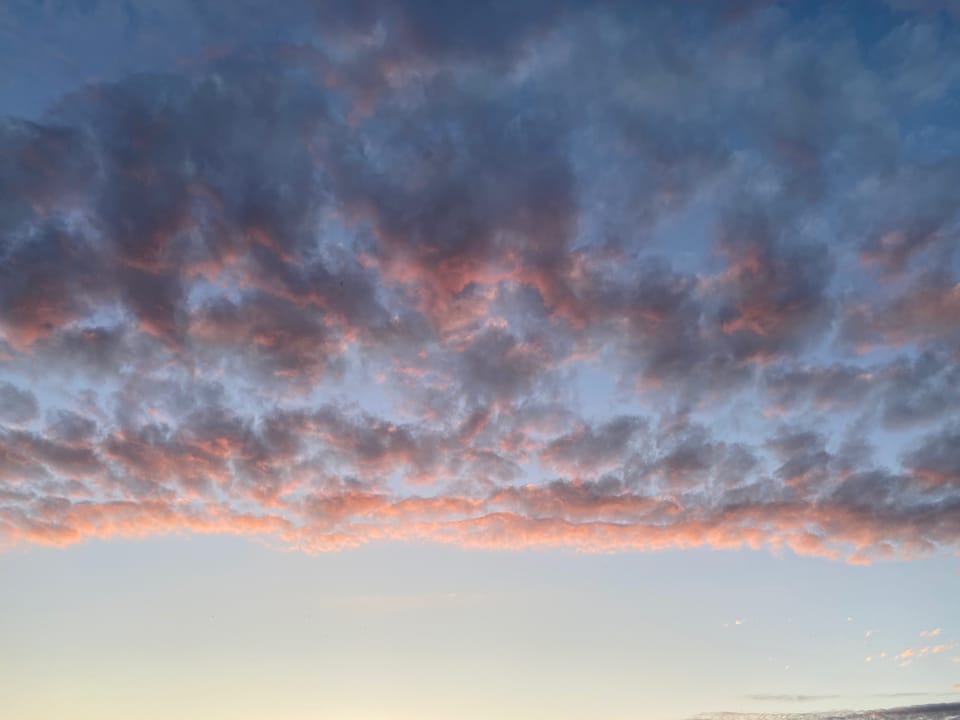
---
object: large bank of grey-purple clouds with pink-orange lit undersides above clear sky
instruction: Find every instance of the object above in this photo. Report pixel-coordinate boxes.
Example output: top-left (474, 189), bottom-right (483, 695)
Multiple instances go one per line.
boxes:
top-left (0, 1), bottom-right (960, 562)
